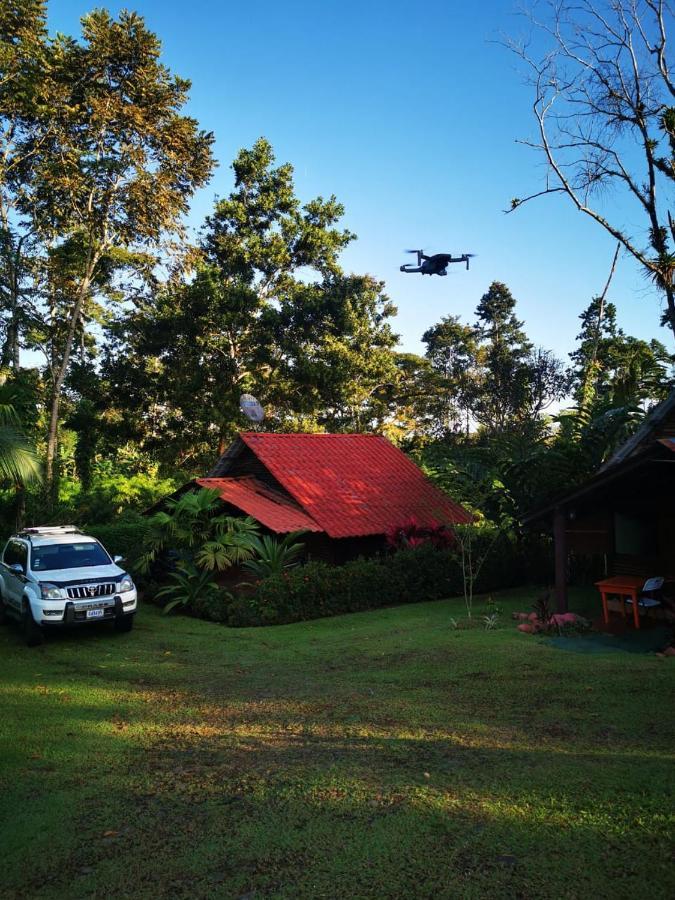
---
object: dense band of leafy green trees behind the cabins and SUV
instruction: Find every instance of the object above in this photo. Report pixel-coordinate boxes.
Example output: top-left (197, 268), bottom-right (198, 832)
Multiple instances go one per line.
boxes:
top-left (0, 0), bottom-right (674, 568)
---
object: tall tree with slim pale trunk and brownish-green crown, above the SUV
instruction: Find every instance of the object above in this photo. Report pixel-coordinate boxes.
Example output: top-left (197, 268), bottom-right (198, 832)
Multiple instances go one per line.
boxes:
top-left (13, 10), bottom-right (213, 482)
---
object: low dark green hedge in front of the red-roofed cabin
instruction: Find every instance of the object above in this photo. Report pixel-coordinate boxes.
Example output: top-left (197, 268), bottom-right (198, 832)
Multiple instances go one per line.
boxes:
top-left (227, 536), bottom-right (548, 626)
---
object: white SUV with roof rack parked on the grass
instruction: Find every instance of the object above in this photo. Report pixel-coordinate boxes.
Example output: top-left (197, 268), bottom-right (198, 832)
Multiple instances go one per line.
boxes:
top-left (0, 525), bottom-right (136, 646)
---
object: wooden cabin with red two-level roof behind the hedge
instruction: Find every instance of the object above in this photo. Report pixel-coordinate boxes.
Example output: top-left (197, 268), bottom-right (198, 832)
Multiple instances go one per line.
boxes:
top-left (164, 432), bottom-right (472, 563)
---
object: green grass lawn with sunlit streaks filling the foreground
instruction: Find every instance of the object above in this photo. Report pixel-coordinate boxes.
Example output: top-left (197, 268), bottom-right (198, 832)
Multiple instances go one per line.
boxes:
top-left (0, 590), bottom-right (675, 900)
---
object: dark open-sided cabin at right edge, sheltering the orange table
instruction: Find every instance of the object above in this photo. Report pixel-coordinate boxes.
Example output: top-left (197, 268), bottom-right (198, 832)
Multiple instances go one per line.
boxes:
top-left (524, 391), bottom-right (675, 611)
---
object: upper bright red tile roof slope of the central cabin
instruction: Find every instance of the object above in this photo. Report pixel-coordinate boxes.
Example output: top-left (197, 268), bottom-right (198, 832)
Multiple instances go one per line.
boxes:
top-left (240, 432), bottom-right (471, 538)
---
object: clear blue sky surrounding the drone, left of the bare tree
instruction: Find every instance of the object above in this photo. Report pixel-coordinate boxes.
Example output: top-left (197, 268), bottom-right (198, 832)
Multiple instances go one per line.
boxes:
top-left (50, 0), bottom-right (672, 358)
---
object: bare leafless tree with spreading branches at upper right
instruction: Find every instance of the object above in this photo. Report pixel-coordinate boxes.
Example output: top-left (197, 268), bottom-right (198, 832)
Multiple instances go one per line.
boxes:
top-left (509, 0), bottom-right (675, 334)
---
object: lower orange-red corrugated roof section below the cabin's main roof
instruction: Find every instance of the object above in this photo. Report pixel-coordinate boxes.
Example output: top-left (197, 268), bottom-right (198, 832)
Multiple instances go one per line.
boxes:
top-left (197, 477), bottom-right (323, 534)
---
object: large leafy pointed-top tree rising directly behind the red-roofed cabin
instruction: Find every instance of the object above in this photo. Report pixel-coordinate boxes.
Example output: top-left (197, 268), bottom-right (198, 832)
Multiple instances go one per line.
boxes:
top-left (104, 138), bottom-right (398, 468)
